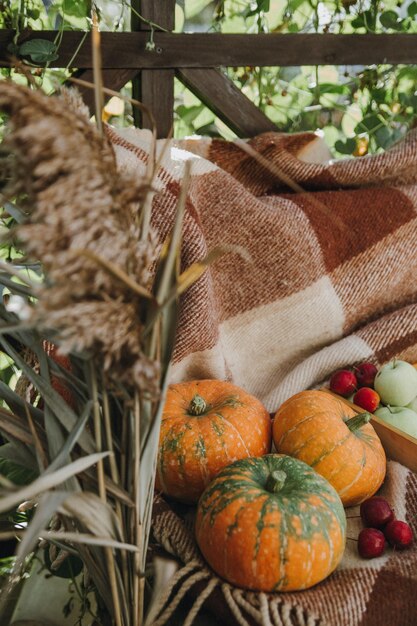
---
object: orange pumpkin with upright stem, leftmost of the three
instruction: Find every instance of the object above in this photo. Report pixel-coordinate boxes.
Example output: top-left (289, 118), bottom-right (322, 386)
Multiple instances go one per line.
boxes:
top-left (156, 380), bottom-right (272, 503)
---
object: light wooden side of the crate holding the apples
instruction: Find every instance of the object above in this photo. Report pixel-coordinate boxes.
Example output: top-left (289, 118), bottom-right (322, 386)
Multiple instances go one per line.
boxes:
top-left (321, 388), bottom-right (417, 472)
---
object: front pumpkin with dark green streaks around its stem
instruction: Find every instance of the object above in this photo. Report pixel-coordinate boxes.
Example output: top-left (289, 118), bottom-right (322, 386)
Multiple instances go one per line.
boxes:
top-left (196, 454), bottom-right (346, 592)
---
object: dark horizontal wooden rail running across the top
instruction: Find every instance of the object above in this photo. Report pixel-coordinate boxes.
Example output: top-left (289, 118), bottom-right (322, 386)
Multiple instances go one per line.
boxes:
top-left (0, 30), bottom-right (417, 69)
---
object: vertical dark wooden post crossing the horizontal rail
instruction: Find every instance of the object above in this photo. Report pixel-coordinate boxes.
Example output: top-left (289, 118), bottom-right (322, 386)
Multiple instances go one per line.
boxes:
top-left (131, 0), bottom-right (175, 137)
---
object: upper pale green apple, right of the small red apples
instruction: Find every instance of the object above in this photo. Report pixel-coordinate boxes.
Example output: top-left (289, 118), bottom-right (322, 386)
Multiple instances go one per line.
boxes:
top-left (374, 359), bottom-right (417, 406)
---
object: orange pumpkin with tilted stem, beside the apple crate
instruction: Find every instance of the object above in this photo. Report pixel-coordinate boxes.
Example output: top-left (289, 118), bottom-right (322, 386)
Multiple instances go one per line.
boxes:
top-left (273, 391), bottom-right (386, 506)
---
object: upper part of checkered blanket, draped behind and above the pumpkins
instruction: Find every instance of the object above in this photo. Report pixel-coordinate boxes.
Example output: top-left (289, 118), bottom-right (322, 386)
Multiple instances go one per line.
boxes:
top-left (109, 129), bottom-right (417, 412)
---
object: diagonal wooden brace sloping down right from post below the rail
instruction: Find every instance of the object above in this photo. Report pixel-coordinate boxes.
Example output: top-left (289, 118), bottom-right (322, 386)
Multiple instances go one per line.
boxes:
top-left (177, 69), bottom-right (277, 137)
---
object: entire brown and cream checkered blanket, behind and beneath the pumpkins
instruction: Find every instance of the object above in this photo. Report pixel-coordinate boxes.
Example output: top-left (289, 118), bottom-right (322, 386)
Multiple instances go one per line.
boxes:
top-left (108, 129), bottom-right (417, 626)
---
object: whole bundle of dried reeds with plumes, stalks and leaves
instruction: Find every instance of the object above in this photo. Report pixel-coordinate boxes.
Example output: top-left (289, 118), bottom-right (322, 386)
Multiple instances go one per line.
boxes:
top-left (0, 81), bottom-right (191, 626)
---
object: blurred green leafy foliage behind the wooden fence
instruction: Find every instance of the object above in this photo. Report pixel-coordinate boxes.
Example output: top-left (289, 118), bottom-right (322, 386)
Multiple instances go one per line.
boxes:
top-left (0, 0), bottom-right (417, 156)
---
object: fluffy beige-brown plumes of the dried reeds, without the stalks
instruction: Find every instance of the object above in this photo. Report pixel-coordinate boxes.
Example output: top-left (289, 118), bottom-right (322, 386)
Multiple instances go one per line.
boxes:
top-left (0, 81), bottom-right (159, 394)
